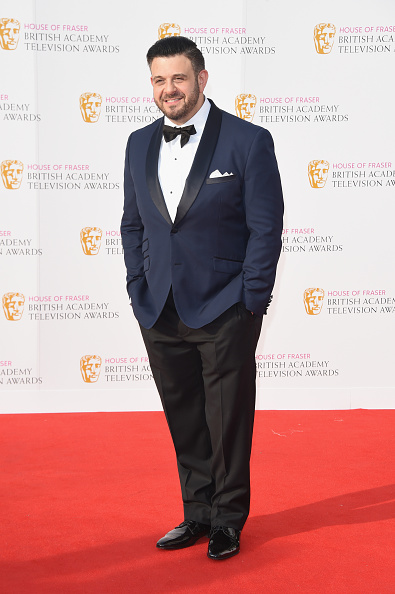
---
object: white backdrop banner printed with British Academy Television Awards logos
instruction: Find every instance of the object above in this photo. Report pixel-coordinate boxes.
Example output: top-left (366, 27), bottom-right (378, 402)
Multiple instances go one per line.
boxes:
top-left (0, 0), bottom-right (395, 413)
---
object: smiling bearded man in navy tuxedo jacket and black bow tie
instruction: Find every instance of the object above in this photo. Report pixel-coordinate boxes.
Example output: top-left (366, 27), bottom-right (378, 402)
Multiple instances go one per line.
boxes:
top-left (121, 36), bottom-right (283, 559)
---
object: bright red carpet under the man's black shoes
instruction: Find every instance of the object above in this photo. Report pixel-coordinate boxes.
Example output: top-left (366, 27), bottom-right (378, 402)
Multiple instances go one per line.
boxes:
top-left (0, 410), bottom-right (395, 594)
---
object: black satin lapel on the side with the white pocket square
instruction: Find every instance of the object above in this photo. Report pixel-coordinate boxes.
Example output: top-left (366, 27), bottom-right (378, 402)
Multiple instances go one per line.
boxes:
top-left (174, 101), bottom-right (222, 225)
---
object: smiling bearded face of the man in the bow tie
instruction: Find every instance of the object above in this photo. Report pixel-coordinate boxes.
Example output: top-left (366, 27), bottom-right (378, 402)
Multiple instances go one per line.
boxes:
top-left (151, 55), bottom-right (208, 125)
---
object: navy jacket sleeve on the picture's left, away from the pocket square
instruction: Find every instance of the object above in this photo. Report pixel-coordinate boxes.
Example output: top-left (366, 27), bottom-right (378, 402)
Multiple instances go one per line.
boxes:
top-left (121, 134), bottom-right (144, 297)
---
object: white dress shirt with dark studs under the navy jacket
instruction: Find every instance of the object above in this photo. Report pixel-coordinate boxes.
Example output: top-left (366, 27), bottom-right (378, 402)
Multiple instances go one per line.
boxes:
top-left (158, 98), bottom-right (211, 222)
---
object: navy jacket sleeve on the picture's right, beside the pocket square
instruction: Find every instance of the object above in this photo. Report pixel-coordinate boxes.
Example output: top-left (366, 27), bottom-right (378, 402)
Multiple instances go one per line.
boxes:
top-left (243, 128), bottom-right (284, 315)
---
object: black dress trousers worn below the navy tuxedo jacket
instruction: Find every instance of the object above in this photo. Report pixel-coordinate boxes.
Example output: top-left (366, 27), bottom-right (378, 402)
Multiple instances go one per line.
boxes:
top-left (141, 291), bottom-right (262, 529)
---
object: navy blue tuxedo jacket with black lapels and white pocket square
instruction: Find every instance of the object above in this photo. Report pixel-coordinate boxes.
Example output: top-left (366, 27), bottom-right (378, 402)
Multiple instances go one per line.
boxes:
top-left (121, 102), bottom-right (283, 328)
